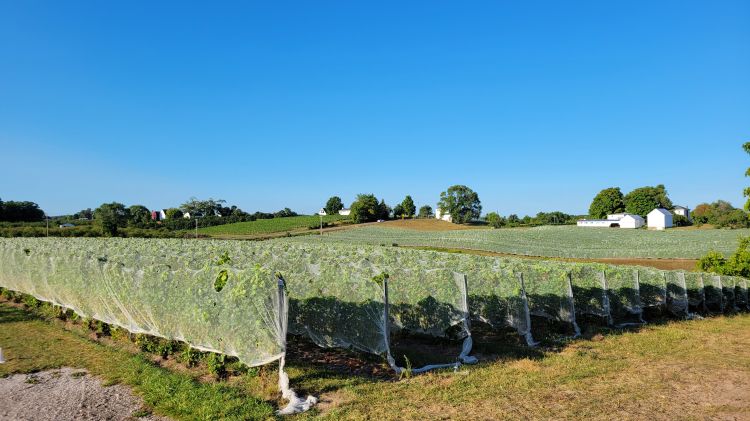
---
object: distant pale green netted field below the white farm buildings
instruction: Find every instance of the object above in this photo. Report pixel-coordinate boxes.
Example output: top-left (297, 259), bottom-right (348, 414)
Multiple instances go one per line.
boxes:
top-left (293, 226), bottom-right (750, 259)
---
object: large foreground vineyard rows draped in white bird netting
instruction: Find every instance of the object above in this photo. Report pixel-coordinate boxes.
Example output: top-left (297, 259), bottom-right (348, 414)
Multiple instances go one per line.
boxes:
top-left (0, 238), bottom-right (750, 414)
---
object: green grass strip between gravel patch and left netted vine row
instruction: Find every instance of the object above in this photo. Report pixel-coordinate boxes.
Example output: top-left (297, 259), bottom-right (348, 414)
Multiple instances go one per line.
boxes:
top-left (0, 304), bottom-right (274, 420)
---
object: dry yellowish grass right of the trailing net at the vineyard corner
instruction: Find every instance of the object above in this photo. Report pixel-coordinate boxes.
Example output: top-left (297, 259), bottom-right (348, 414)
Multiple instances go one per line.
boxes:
top-left (310, 314), bottom-right (750, 420)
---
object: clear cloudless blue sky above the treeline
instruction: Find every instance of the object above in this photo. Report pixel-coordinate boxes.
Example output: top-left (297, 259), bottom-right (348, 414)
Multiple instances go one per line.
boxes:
top-left (0, 0), bottom-right (750, 215)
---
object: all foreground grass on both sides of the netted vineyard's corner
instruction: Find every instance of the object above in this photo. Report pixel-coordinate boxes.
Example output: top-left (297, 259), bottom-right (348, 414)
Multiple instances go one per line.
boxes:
top-left (0, 304), bottom-right (750, 420)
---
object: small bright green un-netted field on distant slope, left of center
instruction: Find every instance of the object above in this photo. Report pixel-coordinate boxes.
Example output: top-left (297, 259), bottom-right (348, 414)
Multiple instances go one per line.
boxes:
top-left (198, 215), bottom-right (349, 236)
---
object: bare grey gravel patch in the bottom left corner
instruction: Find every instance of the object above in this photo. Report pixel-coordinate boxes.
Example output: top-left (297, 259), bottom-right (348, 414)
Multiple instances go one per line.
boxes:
top-left (0, 368), bottom-right (167, 421)
